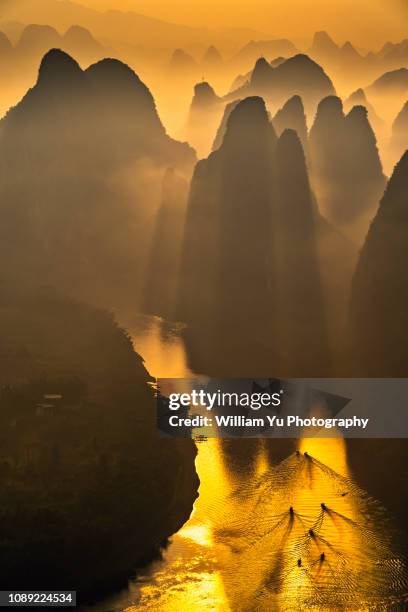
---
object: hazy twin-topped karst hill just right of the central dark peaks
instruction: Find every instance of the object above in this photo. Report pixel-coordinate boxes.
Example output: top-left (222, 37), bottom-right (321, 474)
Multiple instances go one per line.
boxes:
top-left (309, 96), bottom-right (385, 241)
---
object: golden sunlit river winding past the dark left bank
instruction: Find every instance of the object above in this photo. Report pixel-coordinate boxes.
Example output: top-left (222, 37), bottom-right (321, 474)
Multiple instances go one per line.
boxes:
top-left (85, 316), bottom-right (407, 612)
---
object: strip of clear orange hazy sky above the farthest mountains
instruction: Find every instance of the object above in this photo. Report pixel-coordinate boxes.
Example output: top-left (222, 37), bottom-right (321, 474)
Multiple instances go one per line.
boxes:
top-left (76, 0), bottom-right (408, 45)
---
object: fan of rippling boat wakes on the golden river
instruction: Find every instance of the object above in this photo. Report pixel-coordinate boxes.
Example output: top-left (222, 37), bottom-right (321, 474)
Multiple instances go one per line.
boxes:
top-left (213, 452), bottom-right (408, 610)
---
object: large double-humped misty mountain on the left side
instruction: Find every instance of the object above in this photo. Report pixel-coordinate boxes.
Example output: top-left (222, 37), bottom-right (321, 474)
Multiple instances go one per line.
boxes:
top-left (0, 50), bottom-right (195, 305)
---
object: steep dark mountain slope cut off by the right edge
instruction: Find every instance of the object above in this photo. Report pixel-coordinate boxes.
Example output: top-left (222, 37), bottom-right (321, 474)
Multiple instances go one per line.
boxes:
top-left (350, 153), bottom-right (408, 377)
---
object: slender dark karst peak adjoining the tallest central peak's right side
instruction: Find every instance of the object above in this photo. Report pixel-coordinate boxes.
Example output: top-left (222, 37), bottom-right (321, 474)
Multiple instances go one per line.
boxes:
top-left (274, 129), bottom-right (329, 376)
